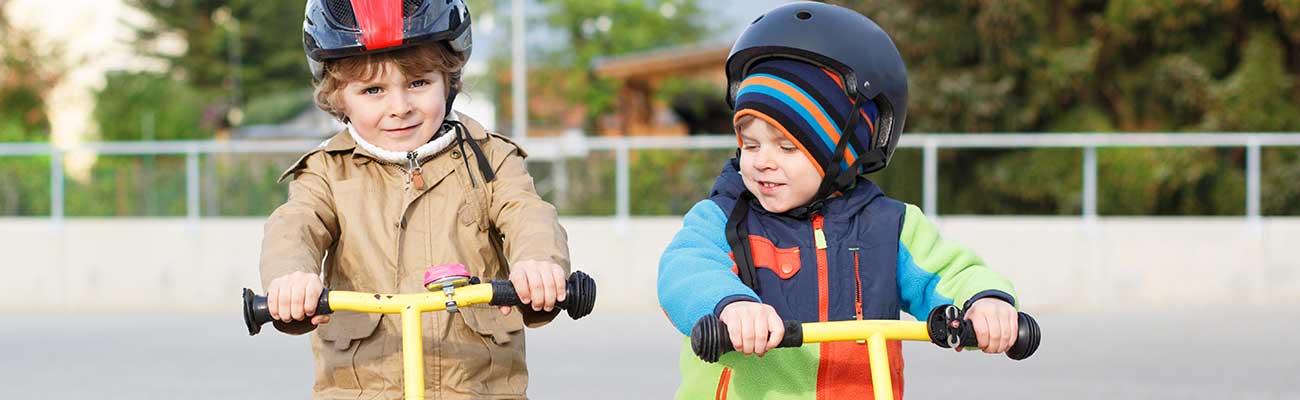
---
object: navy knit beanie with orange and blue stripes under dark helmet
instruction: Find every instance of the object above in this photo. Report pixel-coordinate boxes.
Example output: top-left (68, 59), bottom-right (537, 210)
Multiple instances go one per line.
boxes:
top-left (733, 58), bottom-right (878, 177)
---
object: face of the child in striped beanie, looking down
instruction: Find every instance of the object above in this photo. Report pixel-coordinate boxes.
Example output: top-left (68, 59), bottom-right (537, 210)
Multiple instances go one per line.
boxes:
top-left (737, 119), bottom-right (822, 213)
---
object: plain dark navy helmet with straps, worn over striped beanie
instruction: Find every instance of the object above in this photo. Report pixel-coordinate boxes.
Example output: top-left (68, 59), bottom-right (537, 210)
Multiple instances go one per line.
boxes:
top-left (725, 1), bottom-right (907, 290)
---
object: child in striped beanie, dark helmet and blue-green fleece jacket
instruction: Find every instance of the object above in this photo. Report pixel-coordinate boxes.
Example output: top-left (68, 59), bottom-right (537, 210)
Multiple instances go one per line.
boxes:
top-left (658, 3), bottom-right (1018, 399)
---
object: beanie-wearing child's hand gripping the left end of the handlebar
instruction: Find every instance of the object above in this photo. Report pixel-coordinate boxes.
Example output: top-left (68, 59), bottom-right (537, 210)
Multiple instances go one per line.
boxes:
top-left (718, 301), bottom-right (785, 357)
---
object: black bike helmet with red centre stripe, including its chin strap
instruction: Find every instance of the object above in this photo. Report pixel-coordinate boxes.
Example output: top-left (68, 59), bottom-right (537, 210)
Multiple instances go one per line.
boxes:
top-left (303, 0), bottom-right (495, 182)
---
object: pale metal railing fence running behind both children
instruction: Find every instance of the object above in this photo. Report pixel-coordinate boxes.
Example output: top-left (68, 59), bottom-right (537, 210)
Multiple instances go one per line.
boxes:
top-left (0, 132), bottom-right (1300, 222)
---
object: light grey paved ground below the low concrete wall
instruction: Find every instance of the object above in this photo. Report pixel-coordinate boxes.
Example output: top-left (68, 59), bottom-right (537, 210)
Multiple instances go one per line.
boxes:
top-left (0, 308), bottom-right (1300, 399)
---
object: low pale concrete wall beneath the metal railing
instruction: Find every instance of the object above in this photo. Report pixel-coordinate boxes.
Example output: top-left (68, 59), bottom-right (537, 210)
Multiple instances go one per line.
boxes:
top-left (0, 217), bottom-right (1300, 312)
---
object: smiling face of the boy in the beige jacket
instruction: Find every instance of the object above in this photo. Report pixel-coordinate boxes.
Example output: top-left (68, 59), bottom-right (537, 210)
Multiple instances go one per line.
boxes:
top-left (342, 64), bottom-right (447, 152)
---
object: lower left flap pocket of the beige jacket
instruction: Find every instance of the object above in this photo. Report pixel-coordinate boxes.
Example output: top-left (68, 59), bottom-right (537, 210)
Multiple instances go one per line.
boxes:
top-left (316, 312), bottom-right (380, 390)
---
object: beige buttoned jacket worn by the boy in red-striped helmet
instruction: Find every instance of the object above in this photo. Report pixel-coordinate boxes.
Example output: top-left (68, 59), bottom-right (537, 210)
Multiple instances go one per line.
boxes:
top-left (261, 116), bottom-right (569, 399)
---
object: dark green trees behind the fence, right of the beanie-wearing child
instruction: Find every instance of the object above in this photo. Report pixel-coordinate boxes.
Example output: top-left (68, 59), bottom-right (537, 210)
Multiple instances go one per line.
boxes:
top-left (832, 0), bottom-right (1300, 214)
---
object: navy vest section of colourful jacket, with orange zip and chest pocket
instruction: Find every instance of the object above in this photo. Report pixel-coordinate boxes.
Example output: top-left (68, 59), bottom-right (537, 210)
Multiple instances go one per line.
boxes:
top-left (710, 158), bottom-right (906, 322)
